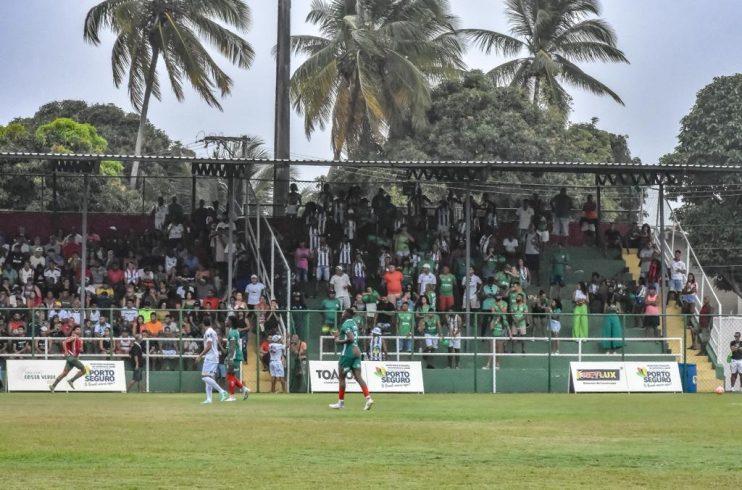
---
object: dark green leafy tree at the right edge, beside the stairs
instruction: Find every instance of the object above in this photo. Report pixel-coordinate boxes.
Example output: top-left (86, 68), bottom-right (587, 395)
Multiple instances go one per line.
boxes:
top-left (661, 74), bottom-right (742, 295)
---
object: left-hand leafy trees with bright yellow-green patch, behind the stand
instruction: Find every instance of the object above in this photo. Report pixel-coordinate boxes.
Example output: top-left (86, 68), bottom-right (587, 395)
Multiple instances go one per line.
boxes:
top-left (0, 100), bottom-right (198, 212)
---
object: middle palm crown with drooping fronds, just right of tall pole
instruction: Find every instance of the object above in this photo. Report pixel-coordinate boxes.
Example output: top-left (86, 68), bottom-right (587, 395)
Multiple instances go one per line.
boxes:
top-left (291, 0), bottom-right (464, 160)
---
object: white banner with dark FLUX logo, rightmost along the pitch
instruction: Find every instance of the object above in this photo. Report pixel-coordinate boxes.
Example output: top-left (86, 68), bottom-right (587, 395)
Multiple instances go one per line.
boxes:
top-left (569, 362), bottom-right (683, 393)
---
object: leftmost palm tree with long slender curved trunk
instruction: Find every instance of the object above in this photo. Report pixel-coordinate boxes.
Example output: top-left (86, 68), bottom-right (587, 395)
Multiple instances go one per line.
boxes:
top-left (83, 0), bottom-right (255, 187)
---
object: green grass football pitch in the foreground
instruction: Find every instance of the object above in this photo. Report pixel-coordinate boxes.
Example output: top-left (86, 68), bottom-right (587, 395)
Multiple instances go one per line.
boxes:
top-left (0, 393), bottom-right (742, 489)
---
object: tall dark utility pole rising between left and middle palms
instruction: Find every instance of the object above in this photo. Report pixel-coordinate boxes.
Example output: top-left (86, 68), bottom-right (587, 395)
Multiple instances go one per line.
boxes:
top-left (273, 0), bottom-right (291, 216)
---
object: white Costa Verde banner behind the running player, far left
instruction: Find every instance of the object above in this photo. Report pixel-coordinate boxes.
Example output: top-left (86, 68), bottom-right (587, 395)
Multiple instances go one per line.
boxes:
top-left (7, 359), bottom-right (126, 393)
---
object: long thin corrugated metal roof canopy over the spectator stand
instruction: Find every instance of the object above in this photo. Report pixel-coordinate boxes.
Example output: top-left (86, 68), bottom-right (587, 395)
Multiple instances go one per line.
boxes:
top-left (0, 152), bottom-right (742, 186)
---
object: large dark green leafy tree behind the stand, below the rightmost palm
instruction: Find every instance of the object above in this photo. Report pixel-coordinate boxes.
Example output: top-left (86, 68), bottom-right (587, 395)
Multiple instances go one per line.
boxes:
top-left (331, 71), bottom-right (640, 210)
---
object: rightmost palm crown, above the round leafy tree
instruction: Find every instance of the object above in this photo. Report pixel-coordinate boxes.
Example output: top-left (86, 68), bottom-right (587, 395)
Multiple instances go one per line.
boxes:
top-left (459, 0), bottom-right (628, 114)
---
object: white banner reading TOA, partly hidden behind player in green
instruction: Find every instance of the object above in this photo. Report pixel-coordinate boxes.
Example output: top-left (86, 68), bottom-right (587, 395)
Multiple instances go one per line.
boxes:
top-left (309, 361), bottom-right (425, 393)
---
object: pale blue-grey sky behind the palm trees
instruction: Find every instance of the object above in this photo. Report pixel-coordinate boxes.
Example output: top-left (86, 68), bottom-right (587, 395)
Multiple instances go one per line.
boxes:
top-left (0, 0), bottom-right (742, 179)
